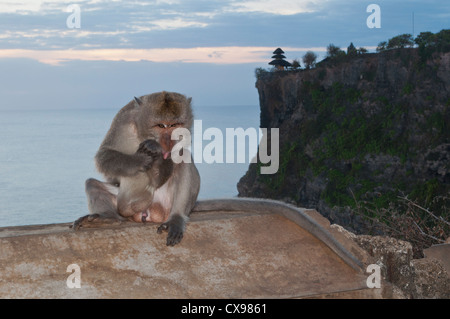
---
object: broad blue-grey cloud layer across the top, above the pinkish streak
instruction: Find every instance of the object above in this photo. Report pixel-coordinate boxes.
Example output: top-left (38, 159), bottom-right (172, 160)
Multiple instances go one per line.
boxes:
top-left (0, 0), bottom-right (448, 54)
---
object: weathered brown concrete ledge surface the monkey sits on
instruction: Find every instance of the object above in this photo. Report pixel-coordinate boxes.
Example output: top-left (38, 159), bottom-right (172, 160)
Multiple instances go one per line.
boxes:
top-left (0, 211), bottom-right (381, 298)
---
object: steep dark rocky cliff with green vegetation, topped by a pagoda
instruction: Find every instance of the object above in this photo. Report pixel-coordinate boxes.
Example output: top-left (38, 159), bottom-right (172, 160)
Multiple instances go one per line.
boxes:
top-left (238, 49), bottom-right (450, 233)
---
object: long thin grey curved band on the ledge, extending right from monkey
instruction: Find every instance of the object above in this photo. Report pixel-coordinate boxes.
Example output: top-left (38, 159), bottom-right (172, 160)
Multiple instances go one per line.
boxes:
top-left (192, 198), bottom-right (363, 272)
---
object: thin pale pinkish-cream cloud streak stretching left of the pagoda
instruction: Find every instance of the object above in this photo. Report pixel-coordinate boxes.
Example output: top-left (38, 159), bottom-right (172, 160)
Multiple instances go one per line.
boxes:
top-left (0, 46), bottom-right (326, 65)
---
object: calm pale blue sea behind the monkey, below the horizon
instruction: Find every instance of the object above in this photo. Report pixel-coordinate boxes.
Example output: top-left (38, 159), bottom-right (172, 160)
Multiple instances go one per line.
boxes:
top-left (0, 106), bottom-right (259, 227)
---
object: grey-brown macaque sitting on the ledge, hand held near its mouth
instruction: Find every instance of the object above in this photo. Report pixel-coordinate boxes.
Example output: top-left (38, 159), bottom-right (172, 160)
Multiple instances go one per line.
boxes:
top-left (72, 92), bottom-right (200, 246)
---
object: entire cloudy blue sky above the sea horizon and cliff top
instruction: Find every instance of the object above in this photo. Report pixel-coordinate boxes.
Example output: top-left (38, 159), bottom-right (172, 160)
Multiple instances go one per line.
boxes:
top-left (0, 0), bottom-right (450, 110)
